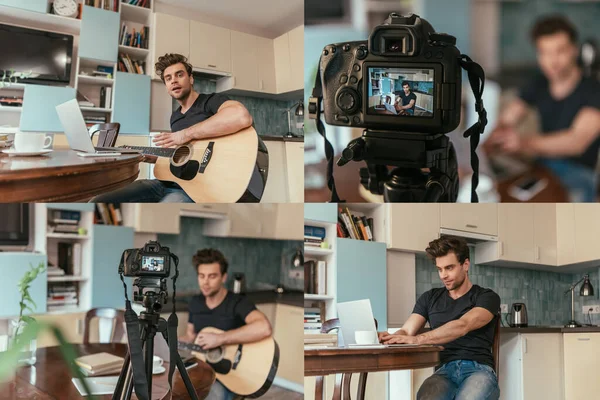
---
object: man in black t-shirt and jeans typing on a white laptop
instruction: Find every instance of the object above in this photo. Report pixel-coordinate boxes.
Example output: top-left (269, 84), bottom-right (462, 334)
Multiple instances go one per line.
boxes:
top-left (379, 237), bottom-right (500, 400)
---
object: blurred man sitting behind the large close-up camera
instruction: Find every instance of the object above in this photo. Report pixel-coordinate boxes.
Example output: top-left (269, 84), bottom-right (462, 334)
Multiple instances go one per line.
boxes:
top-left (485, 16), bottom-right (600, 202)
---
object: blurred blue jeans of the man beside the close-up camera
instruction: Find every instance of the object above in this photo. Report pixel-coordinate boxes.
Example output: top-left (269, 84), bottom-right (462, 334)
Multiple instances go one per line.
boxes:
top-left (540, 159), bottom-right (597, 203)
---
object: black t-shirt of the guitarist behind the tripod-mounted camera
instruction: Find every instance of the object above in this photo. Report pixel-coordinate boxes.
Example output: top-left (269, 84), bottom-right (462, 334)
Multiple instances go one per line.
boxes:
top-left (188, 292), bottom-right (256, 333)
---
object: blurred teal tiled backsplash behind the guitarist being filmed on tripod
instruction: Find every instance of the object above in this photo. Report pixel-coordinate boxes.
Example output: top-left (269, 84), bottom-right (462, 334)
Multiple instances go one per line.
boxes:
top-left (158, 217), bottom-right (304, 291)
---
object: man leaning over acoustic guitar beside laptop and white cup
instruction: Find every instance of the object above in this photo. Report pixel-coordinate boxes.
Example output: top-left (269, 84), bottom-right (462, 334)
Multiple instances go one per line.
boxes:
top-left (92, 54), bottom-right (266, 203)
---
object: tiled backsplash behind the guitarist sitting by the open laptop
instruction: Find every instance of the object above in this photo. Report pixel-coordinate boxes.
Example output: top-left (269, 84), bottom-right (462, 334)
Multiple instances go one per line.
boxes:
top-left (173, 77), bottom-right (304, 136)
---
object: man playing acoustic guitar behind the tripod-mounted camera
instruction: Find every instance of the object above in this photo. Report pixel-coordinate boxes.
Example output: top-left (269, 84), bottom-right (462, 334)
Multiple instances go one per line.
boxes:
top-left (179, 249), bottom-right (279, 400)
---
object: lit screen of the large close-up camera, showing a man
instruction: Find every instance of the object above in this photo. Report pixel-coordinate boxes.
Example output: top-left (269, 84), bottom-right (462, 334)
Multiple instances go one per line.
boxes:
top-left (367, 68), bottom-right (435, 118)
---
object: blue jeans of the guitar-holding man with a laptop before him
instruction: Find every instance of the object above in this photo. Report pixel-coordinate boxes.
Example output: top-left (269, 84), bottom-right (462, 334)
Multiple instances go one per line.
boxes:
top-left (90, 179), bottom-right (194, 203)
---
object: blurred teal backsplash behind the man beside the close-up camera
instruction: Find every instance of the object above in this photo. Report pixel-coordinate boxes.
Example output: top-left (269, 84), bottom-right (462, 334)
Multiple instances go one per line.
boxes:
top-left (500, 0), bottom-right (600, 66)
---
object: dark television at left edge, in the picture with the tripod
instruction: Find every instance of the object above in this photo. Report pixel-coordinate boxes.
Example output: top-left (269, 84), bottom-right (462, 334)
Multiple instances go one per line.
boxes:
top-left (0, 203), bottom-right (34, 251)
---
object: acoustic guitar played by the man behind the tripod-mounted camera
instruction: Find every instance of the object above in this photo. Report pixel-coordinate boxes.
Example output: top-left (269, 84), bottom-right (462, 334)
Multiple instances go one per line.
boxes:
top-left (178, 327), bottom-right (279, 398)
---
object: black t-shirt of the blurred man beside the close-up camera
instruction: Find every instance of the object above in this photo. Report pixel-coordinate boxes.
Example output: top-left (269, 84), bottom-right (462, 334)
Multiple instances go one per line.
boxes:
top-left (519, 74), bottom-right (600, 169)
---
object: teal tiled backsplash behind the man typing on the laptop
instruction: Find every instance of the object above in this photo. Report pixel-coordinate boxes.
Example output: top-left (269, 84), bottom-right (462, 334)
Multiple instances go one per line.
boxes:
top-left (416, 254), bottom-right (600, 326)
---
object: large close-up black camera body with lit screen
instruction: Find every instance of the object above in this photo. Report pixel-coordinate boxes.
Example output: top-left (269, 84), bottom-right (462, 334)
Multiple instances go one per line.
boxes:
top-left (316, 13), bottom-right (461, 134)
